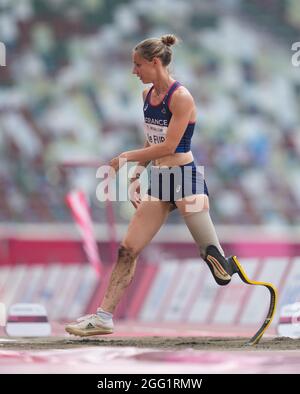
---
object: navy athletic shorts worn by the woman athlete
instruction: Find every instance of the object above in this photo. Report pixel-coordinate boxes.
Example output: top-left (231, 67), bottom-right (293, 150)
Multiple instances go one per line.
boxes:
top-left (147, 161), bottom-right (208, 204)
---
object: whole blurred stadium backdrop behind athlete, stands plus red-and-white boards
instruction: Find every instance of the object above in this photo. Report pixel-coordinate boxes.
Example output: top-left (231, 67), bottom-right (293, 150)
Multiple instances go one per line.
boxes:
top-left (0, 0), bottom-right (300, 336)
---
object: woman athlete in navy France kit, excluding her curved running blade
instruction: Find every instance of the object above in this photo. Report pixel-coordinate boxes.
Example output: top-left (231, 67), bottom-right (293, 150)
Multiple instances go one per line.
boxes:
top-left (66, 35), bottom-right (239, 336)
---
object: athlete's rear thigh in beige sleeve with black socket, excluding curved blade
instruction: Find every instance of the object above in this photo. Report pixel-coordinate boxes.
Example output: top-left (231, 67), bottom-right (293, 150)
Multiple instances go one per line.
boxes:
top-left (176, 194), bottom-right (233, 286)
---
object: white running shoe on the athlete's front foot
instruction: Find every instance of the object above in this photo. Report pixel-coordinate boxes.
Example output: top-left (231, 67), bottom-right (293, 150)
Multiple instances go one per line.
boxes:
top-left (65, 315), bottom-right (114, 337)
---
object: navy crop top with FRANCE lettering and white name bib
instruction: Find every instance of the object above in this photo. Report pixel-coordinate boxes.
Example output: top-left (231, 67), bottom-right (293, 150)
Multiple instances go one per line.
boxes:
top-left (144, 81), bottom-right (195, 153)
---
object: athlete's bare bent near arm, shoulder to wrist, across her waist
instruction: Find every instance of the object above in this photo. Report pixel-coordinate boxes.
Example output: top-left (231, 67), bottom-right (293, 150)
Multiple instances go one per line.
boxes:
top-left (119, 89), bottom-right (194, 162)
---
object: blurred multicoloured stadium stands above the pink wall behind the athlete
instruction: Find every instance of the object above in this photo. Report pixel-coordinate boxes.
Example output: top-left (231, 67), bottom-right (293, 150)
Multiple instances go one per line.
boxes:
top-left (0, 0), bottom-right (300, 225)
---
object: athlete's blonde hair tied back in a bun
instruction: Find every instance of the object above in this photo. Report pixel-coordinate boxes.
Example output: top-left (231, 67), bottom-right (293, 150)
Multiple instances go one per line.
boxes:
top-left (134, 34), bottom-right (179, 67)
